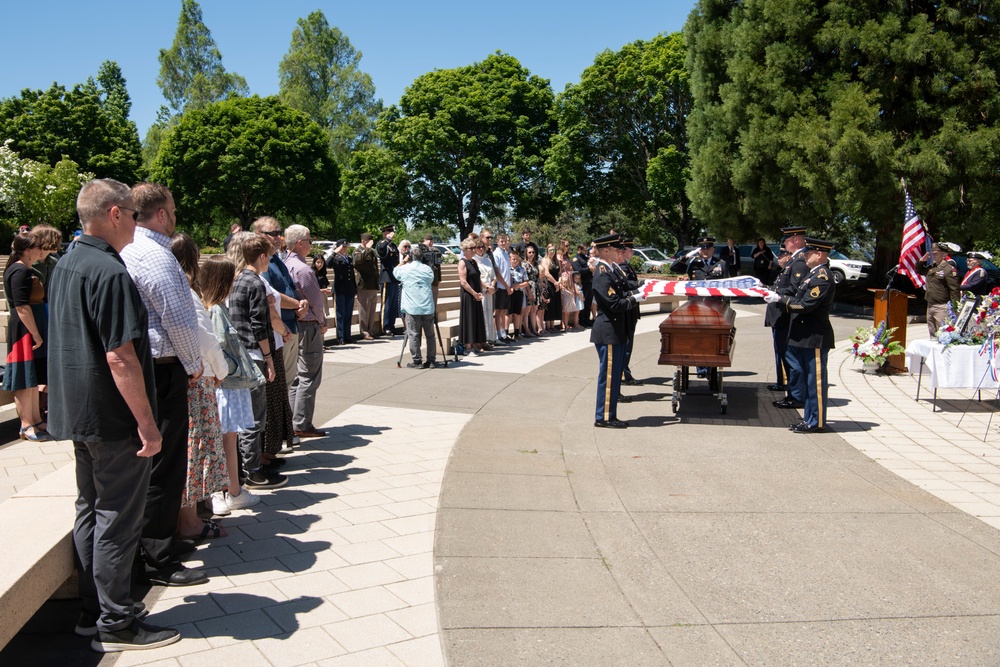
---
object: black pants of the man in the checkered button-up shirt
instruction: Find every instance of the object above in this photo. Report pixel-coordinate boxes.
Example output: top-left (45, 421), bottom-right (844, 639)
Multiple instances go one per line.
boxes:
top-left (139, 362), bottom-right (188, 569)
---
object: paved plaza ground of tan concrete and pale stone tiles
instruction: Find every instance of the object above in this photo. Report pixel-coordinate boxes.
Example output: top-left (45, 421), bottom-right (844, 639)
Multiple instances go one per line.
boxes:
top-left (0, 305), bottom-right (1000, 667)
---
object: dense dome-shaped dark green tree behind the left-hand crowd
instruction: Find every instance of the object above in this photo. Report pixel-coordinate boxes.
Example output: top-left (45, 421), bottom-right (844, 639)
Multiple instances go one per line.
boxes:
top-left (151, 96), bottom-right (340, 243)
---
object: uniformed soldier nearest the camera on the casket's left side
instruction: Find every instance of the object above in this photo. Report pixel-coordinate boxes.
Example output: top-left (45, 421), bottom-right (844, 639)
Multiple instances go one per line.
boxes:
top-left (590, 234), bottom-right (646, 428)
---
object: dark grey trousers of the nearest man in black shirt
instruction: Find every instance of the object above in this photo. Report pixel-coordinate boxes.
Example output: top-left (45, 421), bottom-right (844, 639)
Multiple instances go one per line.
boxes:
top-left (75, 437), bottom-right (152, 632)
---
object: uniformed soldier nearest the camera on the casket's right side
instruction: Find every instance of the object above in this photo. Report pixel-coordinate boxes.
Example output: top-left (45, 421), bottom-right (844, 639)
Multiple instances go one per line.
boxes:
top-left (764, 238), bottom-right (836, 433)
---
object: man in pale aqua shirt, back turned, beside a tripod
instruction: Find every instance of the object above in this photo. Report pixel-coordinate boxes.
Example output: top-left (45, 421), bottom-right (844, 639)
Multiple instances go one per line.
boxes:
top-left (392, 245), bottom-right (440, 368)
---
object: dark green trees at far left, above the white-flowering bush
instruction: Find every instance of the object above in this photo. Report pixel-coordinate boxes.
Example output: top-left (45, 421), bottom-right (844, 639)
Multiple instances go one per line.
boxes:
top-left (0, 61), bottom-right (141, 183)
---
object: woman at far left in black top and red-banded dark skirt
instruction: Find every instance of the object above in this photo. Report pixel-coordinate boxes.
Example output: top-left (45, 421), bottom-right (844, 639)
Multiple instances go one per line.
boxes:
top-left (3, 232), bottom-right (50, 440)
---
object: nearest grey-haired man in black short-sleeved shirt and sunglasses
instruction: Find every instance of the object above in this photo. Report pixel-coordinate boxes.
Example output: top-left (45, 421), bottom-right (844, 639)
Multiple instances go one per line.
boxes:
top-left (48, 179), bottom-right (180, 653)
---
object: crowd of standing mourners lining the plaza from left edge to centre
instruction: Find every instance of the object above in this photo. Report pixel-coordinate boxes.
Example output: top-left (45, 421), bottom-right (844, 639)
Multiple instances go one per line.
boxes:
top-left (3, 179), bottom-right (592, 652)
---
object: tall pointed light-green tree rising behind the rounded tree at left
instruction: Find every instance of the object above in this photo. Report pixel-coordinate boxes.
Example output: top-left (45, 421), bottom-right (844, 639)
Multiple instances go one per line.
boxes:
top-left (156, 0), bottom-right (249, 114)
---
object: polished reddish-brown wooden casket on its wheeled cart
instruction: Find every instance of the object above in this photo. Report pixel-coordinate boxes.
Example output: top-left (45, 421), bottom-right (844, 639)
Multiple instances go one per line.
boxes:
top-left (657, 297), bottom-right (736, 414)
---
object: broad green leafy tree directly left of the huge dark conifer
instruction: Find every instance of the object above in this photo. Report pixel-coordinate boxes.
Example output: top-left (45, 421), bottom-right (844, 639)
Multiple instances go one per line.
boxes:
top-left (545, 33), bottom-right (698, 244)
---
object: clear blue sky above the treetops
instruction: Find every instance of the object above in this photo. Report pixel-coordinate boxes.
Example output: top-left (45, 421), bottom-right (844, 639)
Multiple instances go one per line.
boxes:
top-left (0, 0), bottom-right (694, 137)
